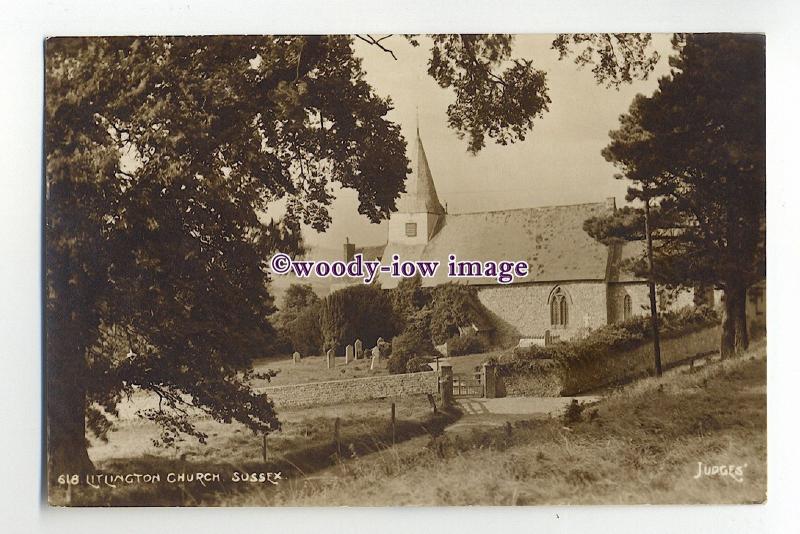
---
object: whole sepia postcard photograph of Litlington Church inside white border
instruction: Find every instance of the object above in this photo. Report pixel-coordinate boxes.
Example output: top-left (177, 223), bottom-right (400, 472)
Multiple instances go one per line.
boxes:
top-left (41, 31), bottom-right (768, 507)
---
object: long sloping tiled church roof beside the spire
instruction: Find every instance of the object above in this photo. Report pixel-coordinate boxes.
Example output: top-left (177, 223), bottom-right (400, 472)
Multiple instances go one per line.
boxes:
top-left (381, 202), bottom-right (648, 288)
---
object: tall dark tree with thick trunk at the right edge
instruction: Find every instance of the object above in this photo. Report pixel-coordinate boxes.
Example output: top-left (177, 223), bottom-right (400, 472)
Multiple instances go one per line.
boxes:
top-left (586, 34), bottom-right (766, 356)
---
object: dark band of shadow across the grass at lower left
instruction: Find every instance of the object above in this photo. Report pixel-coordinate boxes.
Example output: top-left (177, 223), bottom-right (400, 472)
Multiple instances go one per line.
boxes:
top-left (49, 408), bottom-right (463, 506)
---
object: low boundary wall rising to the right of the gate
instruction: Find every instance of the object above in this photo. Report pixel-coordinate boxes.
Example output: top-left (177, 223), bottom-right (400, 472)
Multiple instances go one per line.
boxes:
top-left (500, 326), bottom-right (720, 397)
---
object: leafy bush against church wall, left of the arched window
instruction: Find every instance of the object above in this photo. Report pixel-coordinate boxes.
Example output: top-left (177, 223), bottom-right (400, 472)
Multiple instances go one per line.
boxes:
top-left (431, 282), bottom-right (488, 345)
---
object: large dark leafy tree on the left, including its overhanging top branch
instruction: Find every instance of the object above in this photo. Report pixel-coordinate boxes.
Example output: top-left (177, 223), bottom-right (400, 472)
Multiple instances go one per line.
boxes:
top-left (40, 35), bottom-right (660, 478)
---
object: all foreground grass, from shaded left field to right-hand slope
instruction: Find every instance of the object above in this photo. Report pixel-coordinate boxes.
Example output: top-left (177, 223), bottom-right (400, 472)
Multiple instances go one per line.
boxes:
top-left (51, 342), bottom-right (766, 506)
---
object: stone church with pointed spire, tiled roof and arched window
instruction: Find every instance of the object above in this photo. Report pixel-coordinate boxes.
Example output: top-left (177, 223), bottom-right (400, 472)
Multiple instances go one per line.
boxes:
top-left (344, 131), bottom-right (691, 346)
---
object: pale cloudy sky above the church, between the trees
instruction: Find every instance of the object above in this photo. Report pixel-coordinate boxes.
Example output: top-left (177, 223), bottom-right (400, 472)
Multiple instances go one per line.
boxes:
top-left (303, 34), bottom-right (671, 253)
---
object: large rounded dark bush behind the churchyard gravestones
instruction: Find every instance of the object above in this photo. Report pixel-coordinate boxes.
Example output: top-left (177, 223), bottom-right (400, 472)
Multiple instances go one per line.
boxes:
top-left (320, 284), bottom-right (398, 354)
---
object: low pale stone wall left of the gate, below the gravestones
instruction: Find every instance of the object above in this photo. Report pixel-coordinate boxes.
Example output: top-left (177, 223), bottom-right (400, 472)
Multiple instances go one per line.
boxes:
top-left (256, 371), bottom-right (439, 408)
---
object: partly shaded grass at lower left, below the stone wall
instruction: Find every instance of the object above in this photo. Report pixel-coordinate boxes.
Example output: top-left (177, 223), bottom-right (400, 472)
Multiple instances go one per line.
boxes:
top-left (50, 397), bottom-right (460, 506)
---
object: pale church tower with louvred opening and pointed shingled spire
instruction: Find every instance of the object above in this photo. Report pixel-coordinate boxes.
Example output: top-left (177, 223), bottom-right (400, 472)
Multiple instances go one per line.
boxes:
top-left (389, 128), bottom-right (445, 245)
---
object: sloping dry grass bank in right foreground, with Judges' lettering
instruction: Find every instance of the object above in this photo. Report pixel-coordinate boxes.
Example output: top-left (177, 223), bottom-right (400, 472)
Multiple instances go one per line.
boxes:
top-left (235, 343), bottom-right (766, 506)
